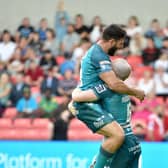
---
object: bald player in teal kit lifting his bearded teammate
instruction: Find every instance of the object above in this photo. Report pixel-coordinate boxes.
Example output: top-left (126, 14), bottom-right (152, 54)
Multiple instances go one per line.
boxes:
top-left (72, 59), bottom-right (141, 168)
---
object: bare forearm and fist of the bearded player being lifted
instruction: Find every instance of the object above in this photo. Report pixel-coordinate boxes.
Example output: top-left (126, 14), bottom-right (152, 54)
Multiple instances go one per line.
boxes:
top-left (99, 70), bottom-right (144, 100)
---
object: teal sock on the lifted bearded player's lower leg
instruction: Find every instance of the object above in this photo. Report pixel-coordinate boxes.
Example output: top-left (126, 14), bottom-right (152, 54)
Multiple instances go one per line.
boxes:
top-left (94, 147), bottom-right (114, 168)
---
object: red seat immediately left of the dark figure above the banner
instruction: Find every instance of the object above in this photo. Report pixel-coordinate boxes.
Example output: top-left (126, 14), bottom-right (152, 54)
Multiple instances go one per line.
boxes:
top-left (32, 118), bottom-right (52, 128)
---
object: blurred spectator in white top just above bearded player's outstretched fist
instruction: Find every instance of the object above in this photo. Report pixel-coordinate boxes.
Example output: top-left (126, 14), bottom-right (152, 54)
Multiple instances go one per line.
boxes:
top-left (138, 70), bottom-right (155, 94)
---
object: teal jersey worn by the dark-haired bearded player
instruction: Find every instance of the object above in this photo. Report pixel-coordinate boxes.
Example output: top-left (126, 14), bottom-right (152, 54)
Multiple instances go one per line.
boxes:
top-left (80, 44), bottom-right (112, 90)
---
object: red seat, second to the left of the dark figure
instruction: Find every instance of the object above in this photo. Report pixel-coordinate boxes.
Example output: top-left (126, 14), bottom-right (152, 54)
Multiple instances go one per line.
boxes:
top-left (14, 118), bottom-right (32, 129)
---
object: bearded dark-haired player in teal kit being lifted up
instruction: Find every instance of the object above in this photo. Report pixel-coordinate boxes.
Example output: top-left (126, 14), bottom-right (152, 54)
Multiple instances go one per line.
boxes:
top-left (69, 25), bottom-right (145, 168)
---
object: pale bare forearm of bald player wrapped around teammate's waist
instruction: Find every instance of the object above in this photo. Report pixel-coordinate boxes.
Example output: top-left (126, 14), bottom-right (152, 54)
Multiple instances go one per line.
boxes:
top-left (72, 88), bottom-right (98, 102)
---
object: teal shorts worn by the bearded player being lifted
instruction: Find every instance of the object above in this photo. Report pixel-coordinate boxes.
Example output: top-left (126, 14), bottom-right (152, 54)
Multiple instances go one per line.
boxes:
top-left (74, 102), bottom-right (114, 132)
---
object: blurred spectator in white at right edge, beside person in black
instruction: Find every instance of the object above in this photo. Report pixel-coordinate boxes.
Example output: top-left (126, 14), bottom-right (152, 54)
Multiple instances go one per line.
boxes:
top-left (154, 53), bottom-right (168, 72)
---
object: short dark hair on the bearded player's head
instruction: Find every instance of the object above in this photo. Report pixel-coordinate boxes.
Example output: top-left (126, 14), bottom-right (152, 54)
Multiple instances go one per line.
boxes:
top-left (102, 24), bottom-right (126, 41)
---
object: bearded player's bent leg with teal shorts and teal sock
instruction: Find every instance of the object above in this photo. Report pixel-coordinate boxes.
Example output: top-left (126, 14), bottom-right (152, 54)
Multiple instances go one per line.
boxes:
top-left (71, 103), bottom-right (124, 168)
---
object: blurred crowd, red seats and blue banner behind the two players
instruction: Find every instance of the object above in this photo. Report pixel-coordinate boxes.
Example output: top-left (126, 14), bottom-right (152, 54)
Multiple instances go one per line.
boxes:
top-left (0, 0), bottom-right (168, 168)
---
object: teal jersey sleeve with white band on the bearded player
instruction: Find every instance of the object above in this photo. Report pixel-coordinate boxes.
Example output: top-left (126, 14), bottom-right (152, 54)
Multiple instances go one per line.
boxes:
top-left (91, 52), bottom-right (112, 74)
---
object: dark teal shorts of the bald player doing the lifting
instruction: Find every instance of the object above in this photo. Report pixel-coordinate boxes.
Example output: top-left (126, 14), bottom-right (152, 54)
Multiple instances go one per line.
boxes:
top-left (106, 134), bottom-right (141, 168)
